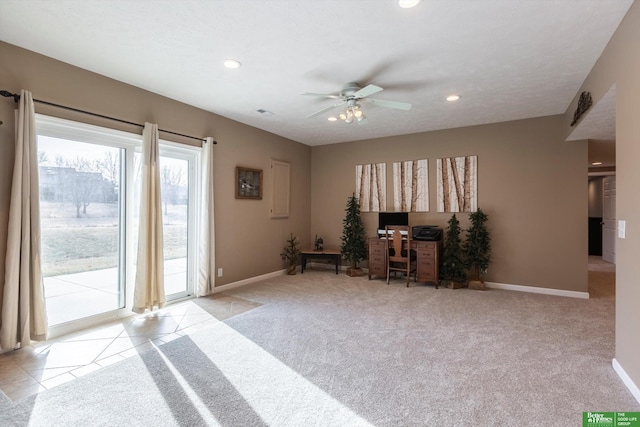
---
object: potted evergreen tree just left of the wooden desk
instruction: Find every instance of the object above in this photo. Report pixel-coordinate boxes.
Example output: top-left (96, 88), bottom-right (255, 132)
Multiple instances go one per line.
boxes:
top-left (340, 194), bottom-right (367, 277)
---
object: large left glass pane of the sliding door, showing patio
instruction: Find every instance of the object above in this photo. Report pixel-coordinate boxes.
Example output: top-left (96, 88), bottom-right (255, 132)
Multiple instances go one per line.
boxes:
top-left (38, 135), bottom-right (125, 326)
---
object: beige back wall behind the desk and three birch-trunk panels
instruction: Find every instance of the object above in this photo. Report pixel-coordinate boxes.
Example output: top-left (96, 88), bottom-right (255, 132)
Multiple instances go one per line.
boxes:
top-left (311, 116), bottom-right (587, 292)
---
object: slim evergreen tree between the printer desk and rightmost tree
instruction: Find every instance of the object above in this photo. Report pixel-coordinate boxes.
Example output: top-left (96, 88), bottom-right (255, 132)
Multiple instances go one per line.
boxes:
top-left (440, 214), bottom-right (467, 289)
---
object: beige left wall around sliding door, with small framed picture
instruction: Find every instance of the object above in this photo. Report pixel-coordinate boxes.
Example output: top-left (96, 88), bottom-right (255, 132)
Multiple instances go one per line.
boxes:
top-left (0, 42), bottom-right (311, 295)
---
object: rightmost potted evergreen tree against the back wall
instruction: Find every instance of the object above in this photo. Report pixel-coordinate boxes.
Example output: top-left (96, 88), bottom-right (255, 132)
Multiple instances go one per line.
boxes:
top-left (464, 208), bottom-right (491, 290)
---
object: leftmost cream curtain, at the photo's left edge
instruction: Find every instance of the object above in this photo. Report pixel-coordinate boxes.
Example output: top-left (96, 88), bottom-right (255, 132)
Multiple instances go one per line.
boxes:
top-left (0, 90), bottom-right (48, 351)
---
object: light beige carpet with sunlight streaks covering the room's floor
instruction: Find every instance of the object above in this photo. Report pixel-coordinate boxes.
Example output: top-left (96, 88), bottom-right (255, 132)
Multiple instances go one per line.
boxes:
top-left (0, 270), bottom-right (640, 426)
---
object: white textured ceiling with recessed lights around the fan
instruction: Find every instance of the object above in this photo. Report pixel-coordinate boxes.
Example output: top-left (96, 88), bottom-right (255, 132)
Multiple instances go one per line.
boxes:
top-left (0, 0), bottom-right (633, 146)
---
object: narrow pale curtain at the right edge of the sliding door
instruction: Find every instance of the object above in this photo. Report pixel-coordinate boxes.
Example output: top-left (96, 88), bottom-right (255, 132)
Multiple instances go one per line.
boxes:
top-left (196, 137), bottom-right (215, 297)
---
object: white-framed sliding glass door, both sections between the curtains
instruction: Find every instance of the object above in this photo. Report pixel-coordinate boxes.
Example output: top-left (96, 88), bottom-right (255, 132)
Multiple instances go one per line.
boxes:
top-left (36, 115), bottom-right (199, 335)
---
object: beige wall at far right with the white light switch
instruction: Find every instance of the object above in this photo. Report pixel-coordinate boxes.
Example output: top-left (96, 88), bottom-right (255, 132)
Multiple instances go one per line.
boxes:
top-left (564, 2), bottom-right (640, 400)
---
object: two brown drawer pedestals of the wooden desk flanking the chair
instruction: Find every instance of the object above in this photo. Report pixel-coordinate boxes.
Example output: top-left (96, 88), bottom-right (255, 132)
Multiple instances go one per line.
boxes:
top-left (369, 238), bottom-right (441, 289)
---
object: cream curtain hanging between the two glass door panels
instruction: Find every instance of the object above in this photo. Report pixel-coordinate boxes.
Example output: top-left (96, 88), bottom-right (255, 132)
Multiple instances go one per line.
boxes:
top-left (132, 123), bottom-right (166, 313)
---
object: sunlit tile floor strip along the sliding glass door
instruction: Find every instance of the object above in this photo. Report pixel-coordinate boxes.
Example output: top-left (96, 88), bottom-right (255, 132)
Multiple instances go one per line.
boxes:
top-left (0, 293), bottom-right (260, 400)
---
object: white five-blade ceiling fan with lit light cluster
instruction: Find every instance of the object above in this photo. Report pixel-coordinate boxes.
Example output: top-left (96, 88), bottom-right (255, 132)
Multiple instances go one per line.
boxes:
top-left (303, 82), bottom-right (411, 124)
